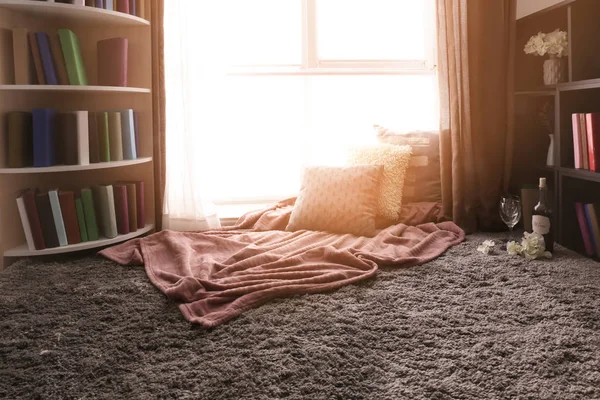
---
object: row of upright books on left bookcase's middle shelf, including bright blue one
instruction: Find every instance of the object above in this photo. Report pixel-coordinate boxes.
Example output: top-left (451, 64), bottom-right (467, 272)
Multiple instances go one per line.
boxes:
top-left (6, 108), bottom-right (140, 168)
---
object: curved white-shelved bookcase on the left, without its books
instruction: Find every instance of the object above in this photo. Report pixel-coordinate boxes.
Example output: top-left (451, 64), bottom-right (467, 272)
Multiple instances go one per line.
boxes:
top-left (0, 0), bottom-right (154, 270)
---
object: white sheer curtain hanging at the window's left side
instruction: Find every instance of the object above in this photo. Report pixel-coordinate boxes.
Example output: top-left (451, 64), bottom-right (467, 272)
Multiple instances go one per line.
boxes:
top-left (163, 1), bottom-right (220, 231)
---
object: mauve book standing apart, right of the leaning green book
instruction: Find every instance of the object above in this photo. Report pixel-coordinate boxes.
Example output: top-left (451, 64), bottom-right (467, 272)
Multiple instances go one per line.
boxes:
top-left (96, 37), bottom-right (129, 86)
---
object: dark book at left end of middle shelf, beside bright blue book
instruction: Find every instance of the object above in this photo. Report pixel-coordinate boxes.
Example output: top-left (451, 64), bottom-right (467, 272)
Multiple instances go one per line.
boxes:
top-left (7, 111), bottom-right (33, 168)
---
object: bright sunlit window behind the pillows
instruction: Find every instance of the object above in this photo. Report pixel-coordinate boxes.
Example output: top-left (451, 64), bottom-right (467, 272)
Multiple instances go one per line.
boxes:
top-left (165, 0), bottom-right (438, 204)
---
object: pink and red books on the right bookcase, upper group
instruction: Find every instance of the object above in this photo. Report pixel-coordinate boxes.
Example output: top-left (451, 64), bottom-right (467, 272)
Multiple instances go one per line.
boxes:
top-left (572, 113), bottom-right (600, 171)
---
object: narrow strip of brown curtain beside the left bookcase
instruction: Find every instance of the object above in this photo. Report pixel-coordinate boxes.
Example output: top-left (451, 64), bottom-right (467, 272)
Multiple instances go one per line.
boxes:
top-left (150, 0), bottom-right (166, 231)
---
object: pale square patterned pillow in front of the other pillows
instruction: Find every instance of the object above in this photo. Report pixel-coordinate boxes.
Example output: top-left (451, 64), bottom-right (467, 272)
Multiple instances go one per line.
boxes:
top-left (285, 165), bottom-right (383, 236)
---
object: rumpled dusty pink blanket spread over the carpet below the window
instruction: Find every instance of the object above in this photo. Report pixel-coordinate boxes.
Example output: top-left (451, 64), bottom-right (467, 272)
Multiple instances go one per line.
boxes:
top-left (99, 200), bottom-right (465, 327)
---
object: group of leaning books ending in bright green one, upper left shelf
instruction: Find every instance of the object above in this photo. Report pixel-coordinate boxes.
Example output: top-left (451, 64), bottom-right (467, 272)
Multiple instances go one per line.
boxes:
top-left (12, 28), bottom-right (88, 85)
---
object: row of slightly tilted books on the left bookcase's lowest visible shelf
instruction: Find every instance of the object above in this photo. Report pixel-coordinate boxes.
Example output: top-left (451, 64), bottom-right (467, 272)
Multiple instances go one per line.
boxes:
top-left (17, 181), bottom-right (146, 250)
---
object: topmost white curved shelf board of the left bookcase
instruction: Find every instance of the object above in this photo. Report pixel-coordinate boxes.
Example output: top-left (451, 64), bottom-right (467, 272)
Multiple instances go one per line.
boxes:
top-left (0, 0), bottom-right (150, 26)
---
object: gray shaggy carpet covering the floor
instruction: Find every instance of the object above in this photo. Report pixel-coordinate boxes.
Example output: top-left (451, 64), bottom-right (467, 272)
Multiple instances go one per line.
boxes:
top-left (0, 235), bottom-right (600, 399)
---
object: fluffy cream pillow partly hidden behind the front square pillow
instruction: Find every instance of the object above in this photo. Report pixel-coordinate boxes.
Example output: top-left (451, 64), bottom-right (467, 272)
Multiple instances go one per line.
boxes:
top-left (348, 144), bottom-right (412, 221)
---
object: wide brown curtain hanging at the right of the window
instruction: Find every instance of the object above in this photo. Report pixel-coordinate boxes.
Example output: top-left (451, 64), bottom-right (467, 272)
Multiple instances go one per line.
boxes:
top-left (437, 0), bottom-right (516, 231)
